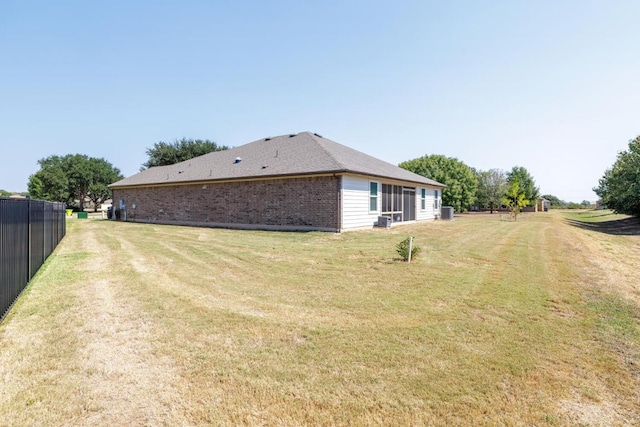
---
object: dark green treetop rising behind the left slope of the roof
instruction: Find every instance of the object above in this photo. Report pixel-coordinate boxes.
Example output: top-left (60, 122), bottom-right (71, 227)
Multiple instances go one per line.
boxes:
top-left (140, 138), bottom-right (230, 170)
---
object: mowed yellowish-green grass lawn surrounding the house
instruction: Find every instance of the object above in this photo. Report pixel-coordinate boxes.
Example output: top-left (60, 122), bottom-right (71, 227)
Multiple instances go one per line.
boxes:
top-left (0, 211), bottom-right (640, 425)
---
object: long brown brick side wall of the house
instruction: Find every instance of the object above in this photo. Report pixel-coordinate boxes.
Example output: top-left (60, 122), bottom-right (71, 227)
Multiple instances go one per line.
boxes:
top-left (113, 176), bottom-right (340, 230)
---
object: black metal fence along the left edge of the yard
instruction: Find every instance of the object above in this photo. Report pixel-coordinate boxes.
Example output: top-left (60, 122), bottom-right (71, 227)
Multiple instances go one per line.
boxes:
top-left (0, 198), bottom-right (67, 319)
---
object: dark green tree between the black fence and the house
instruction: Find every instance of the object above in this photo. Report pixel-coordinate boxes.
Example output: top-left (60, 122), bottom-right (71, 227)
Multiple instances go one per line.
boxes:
top-left (28, 154), bottom-right (123, 209)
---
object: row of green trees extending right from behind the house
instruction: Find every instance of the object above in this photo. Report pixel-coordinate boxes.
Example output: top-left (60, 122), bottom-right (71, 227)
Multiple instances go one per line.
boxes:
top-left (399, 154), bottom-right (540, 215)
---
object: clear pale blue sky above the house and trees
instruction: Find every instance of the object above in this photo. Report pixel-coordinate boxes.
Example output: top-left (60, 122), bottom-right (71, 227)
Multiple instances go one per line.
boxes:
top-left (0, 0), bottom-right (640, 202)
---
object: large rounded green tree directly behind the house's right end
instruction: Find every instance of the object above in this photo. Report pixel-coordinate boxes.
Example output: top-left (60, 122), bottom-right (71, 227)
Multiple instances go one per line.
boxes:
top-left (398, 154), bottom-right (478, 212)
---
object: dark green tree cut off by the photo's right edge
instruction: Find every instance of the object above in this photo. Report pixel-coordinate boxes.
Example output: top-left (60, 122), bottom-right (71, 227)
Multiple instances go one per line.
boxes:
top-left (593, 135), bottom-right (640, 216)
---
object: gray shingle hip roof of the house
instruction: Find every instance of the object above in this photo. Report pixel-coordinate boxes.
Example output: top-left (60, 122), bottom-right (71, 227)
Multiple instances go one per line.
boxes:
top-left (111, 132), bottom-right (444, 188)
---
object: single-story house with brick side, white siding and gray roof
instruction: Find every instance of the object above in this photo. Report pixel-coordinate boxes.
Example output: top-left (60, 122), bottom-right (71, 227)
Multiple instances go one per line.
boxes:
top-left (110, 132), bottom-right (444, 232)
